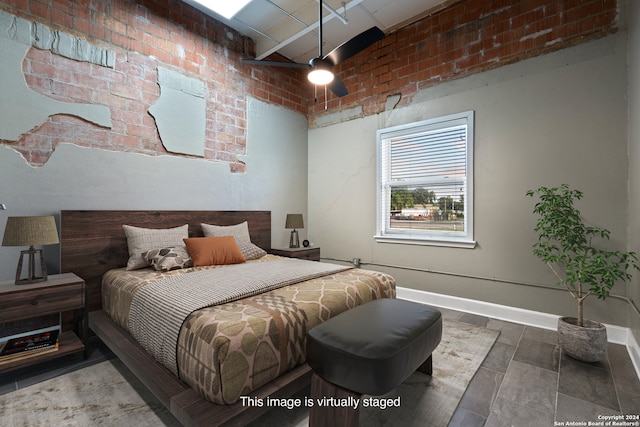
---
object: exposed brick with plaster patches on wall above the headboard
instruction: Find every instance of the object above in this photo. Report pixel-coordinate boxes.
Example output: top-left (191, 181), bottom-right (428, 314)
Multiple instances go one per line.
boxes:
top-left (0, 0), bottom-right (308, 172)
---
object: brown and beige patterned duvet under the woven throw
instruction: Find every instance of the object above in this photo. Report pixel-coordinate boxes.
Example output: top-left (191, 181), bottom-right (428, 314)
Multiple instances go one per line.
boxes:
top-left (102, 255), bottom-right (395, 404)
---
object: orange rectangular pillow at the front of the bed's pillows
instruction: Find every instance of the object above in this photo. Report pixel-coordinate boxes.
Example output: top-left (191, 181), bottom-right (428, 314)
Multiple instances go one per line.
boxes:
top-left (184, 236), bottom-right (245, 267)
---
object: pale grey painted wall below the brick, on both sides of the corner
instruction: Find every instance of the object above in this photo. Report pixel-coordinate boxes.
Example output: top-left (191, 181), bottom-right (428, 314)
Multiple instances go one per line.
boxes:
top-left (0, 11), bottom-right (640, 340)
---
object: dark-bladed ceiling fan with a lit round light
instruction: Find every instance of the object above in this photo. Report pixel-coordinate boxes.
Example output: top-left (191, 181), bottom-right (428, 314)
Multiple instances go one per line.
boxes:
top-left (241, 0), bottom-right (384, 97)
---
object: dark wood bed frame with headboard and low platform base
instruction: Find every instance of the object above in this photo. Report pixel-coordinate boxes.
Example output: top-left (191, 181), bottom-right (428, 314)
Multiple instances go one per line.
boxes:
top-left (60, 210), bottom-right (311, 426)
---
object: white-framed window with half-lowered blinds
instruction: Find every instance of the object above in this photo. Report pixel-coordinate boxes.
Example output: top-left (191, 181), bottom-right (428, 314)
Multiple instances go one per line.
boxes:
top-left (375, 111), bottom-right (475, 248)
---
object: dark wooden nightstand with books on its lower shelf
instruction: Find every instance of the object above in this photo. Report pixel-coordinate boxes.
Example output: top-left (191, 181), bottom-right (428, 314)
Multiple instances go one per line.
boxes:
top-left (0, 273), bottom-right (88, 373)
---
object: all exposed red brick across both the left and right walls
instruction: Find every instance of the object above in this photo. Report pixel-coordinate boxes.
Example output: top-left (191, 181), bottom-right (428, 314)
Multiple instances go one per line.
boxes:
top-left (0, 0), bottom-right (617, 166)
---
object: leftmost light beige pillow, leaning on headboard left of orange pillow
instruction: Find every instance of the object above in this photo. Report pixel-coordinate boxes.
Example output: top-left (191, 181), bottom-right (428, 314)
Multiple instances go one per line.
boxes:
top-left (122, 224), bottom-right (189, 270)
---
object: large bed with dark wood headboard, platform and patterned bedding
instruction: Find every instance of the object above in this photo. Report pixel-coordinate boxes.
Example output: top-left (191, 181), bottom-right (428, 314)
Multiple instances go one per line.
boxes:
top-left (61, 211), bottom-right (395, 425)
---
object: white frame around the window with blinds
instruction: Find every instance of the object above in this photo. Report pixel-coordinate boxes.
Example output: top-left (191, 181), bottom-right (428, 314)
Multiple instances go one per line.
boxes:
top-left (374, 110), bottom-right (476, 248)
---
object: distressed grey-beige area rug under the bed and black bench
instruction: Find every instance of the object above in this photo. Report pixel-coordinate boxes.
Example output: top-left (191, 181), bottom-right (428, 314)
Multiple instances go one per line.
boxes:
top-left (0, 319), bottom-right (499, 427)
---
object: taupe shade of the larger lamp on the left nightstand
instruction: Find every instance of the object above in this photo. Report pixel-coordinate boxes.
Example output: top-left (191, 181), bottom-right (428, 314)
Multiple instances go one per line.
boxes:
top-left (2, 216), bottom-right (60, 246)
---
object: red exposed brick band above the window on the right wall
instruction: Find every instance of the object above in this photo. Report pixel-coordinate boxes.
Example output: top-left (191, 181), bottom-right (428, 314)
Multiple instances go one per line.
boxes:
top-left (309, 0), bottom-right (618, 126)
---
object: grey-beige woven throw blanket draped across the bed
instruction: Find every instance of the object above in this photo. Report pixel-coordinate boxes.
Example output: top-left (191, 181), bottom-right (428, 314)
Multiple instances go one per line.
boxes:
top-left (129, 258), bottom-right (349, 375)
